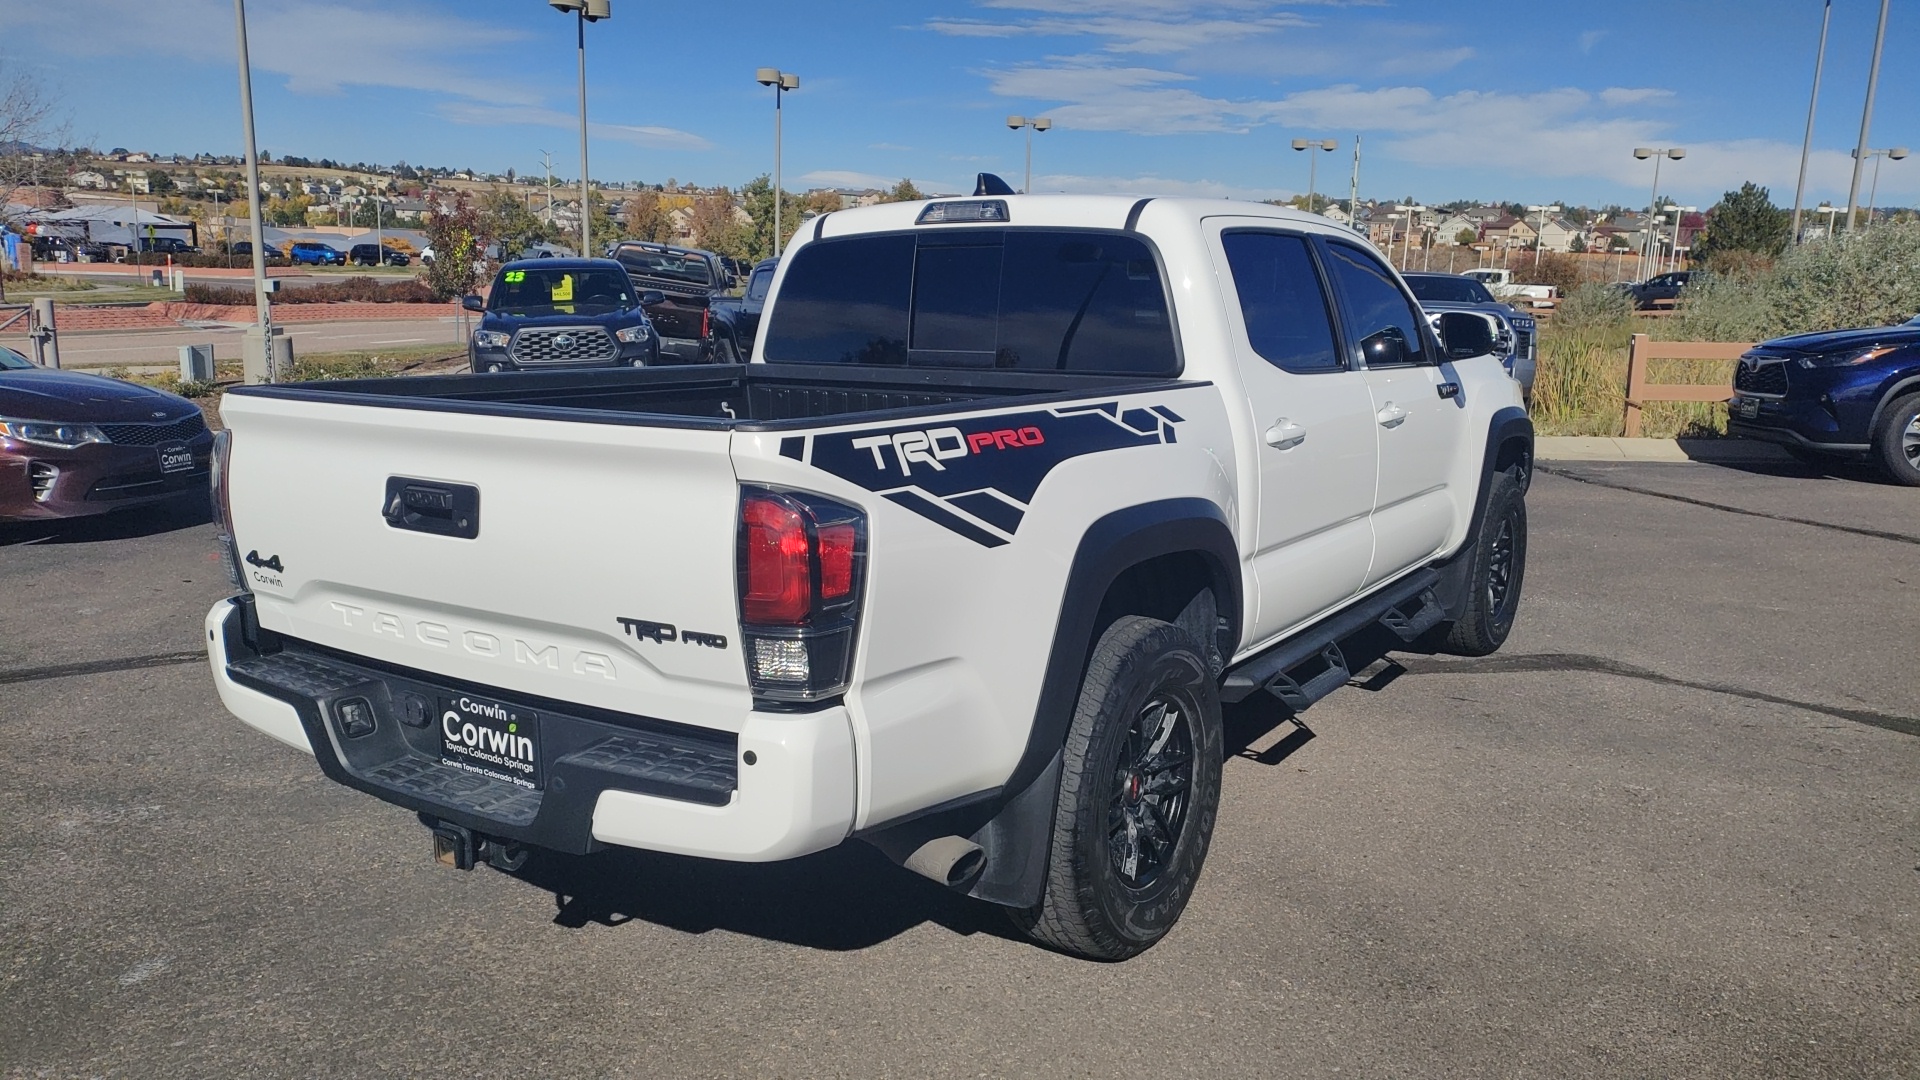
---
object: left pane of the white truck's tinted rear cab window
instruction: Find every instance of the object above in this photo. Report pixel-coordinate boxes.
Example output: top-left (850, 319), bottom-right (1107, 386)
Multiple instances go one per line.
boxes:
top-left (766, 234), bottom-right (914, 363)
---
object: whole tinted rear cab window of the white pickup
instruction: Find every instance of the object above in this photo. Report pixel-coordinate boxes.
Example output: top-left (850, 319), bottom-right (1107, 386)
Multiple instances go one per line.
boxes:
top-left (766, 229), bottom-right (1179, 375)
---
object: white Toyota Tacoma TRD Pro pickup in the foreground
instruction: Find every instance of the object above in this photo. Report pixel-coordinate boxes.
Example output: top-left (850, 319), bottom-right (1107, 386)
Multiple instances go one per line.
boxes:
top-left (205, 187), bottom-right (1532, 959)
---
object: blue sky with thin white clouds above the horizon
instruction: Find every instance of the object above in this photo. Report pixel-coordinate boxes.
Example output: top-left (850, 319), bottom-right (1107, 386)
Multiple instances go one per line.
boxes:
top-left (0, 0), bottom-right (1920, 206)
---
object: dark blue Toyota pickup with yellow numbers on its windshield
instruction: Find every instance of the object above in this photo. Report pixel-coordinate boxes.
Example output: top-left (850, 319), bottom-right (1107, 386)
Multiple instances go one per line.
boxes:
top-left (461, 259), bottom-right (660, 371)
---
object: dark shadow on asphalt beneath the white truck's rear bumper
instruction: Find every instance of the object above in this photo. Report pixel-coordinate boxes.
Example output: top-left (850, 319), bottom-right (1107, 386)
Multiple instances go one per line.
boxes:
top-left (513, 826), bottom-right (1023, 951)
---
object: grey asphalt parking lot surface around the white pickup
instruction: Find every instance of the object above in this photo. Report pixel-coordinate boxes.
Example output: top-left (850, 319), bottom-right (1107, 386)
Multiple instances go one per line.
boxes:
top-left (0, 463), bottom-right (1920, 1078)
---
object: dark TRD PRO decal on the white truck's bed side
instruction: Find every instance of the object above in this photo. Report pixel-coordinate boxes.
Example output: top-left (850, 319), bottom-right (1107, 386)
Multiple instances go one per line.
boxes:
top-left (781, 402), bottom-right (1181, 548)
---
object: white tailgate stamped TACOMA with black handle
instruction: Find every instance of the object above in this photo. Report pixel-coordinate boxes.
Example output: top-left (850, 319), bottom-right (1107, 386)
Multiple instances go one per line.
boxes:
top-left (223, 394), bottom-right (751, 730)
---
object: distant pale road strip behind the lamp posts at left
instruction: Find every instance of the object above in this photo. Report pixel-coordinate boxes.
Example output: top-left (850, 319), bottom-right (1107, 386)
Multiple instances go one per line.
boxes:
top-left (0, 319), bottom-right (465, 367)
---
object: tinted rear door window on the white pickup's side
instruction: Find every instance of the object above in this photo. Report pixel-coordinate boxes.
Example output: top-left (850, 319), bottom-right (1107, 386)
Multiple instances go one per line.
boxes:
top-left (1221, 233), bottom-right (1346, 373)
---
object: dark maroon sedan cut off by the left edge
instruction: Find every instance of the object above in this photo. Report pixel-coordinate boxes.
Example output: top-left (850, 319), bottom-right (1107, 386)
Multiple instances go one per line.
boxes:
top-left (0, 348), bottom-right (213, 521)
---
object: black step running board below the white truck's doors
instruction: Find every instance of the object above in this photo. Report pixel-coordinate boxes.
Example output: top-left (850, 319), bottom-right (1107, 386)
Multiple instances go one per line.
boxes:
top-left (1219, 569), bottom-right (1446, 713)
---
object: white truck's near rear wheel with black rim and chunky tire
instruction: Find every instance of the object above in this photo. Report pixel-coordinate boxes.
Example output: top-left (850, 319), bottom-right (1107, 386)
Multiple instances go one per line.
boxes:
top-left (1012, 615), bottom-right (1223, 961)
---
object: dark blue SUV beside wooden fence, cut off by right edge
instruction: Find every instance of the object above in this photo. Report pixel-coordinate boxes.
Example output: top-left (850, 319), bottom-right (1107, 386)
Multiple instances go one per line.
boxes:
top-left (1726, 317), bottom-right (1920, 478)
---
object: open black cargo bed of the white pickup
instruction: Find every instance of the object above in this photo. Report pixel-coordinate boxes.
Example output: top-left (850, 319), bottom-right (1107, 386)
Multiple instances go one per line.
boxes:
top-left (232, 363), bottom-right (1173, 430)
